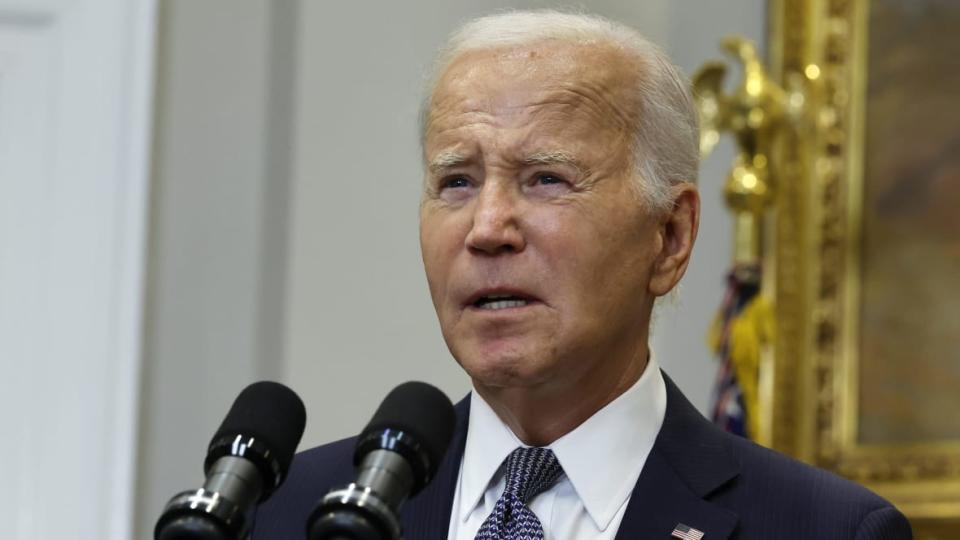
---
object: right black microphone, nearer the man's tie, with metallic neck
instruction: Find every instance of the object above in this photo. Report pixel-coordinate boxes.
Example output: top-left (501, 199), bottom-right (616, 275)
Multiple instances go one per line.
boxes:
top-left (307, 382), bottom-right (456, 540)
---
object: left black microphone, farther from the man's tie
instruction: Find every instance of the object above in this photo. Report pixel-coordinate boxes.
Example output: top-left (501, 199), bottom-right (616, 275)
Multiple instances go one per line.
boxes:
top-left (153, 381), bottom-right (307, 540)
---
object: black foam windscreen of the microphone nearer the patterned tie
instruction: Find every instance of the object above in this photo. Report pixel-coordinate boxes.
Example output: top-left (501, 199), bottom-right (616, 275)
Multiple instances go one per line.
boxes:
top-left (359, 382), bottom-right (456, 477)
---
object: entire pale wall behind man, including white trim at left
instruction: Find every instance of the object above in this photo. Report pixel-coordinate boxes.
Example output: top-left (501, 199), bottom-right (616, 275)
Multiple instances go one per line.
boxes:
top-left (0, 0), bottom-right (766, 540)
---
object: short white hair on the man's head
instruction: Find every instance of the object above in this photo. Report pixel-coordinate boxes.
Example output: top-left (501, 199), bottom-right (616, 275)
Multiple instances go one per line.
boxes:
top-left (420, 10), bottom-right (700, 211)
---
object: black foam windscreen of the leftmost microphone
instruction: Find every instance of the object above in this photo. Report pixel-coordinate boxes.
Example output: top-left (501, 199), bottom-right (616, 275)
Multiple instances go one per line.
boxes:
top-left (207, 381), bottom-right (307, 478)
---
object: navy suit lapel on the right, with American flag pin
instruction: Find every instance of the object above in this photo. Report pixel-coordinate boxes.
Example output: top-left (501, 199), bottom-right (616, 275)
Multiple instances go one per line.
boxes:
top-left (616, 374), bottom-right (739, 540)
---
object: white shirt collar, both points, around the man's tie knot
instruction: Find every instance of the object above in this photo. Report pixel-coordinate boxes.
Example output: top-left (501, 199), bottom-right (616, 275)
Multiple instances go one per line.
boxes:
top-left (459, 354), bottom-right (667, 530)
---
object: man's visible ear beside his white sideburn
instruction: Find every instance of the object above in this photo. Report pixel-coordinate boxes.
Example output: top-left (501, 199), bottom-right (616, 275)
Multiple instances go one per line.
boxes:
top-left (648, 182), bottom-right (700, 296)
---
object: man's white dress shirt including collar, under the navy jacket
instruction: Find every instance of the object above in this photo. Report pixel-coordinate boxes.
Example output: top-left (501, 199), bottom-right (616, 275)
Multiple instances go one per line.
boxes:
top-left (448, 355), bottom-right (667, 540)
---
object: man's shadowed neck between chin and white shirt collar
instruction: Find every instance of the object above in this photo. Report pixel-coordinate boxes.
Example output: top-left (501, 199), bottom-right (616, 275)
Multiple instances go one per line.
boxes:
top-left (474, 349), bottom-right (649, 446)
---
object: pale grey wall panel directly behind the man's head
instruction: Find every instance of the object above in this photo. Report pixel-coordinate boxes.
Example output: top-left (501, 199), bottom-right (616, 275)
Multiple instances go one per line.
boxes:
top-left (283, 0), bottom-right (765, 445)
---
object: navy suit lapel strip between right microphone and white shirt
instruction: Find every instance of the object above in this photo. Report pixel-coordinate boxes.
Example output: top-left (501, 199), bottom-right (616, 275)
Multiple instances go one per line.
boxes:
top-left (400, 396), bottom-right (470, 540)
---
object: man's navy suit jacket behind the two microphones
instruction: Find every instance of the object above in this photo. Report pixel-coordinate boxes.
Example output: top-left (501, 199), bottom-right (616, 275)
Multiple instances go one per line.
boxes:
top-left (253, 376), bottom-right (911, 540)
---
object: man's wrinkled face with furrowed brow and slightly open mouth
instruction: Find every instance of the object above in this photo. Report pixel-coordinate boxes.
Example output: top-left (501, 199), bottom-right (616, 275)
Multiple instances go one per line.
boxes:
top-left (420, 43), bottom-right (676, 394)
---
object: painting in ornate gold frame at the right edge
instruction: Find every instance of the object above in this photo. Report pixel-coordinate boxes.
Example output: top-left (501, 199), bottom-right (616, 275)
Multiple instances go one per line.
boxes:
top-left (761, 0), bottom-right (960, 539)
